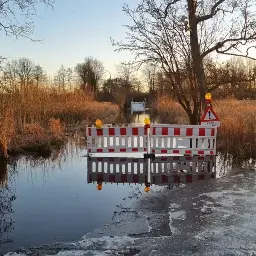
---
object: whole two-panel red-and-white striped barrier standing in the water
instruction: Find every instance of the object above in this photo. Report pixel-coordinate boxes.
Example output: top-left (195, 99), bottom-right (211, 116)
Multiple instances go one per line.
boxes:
top-left (87, 125), bottom-right (217, 156)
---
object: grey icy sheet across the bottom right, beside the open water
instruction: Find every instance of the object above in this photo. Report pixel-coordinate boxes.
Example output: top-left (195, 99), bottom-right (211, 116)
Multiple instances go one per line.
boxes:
top-left (5, 170), bottom-right (256, 256)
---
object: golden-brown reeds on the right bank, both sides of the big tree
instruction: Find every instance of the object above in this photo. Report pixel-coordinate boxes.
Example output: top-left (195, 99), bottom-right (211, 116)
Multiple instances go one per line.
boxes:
top-left (155, 98), bottom-right (256, 163)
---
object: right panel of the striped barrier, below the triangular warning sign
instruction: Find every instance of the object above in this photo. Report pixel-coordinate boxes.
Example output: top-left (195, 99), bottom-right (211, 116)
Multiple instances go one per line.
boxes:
top-left (150, 125), bottom-right (217, 155)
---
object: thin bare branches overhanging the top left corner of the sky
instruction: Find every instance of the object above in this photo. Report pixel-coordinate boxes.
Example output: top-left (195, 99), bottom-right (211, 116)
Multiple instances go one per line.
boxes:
top-left (0, 0), bottom-right (54, 38)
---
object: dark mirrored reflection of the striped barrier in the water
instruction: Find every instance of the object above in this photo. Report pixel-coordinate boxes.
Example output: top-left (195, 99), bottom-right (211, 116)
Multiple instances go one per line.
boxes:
top-left (87, 156), bottom-right (216, 191)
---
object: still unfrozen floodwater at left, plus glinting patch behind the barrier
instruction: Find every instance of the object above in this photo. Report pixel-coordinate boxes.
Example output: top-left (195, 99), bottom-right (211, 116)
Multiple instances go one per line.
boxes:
top-left (0, 114), bottom-right (153, 254)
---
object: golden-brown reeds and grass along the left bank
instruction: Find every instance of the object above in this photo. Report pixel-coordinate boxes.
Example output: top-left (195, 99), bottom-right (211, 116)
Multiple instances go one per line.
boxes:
top-left (0, 87), bottom-right (119, 157)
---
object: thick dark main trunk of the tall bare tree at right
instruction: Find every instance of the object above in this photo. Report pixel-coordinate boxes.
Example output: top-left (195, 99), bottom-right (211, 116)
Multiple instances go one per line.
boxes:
top-left (187, 0), bottom-right (206, 110)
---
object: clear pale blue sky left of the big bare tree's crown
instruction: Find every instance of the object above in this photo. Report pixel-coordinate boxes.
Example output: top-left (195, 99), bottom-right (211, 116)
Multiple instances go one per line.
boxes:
top-left (0, 0), bottom-right (135, 75)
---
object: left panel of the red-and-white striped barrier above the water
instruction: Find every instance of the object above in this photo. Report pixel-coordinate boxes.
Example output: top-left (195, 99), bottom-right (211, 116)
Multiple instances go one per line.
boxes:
top-left (87, 127), bottom-right (148, 153)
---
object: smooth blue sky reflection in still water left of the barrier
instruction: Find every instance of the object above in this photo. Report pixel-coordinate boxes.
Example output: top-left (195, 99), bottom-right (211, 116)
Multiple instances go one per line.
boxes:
top-left (0, 144), bottom-right (143, 254)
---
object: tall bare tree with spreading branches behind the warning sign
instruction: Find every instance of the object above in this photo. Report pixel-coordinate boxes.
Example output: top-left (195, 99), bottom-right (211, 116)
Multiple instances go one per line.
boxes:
top-left (113, 0), bottom-right (256, 123)
